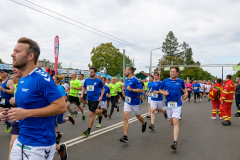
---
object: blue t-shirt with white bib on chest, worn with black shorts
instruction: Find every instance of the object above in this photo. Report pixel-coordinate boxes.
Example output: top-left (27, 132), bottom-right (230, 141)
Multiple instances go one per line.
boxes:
top-left (83, 78), bottom-right (103, 101)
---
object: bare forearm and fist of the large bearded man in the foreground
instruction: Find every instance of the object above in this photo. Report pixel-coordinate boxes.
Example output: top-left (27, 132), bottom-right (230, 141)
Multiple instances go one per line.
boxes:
top-left (8, 97), bottom-right (67, 121)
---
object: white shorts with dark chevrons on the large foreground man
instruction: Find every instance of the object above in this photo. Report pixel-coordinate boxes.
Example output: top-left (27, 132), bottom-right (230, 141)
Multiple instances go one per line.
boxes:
top-left (10, 139), bottom-right (56, 160)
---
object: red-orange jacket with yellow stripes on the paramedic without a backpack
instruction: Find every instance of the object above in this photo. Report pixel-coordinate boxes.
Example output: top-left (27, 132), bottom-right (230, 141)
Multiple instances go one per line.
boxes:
top-left (220, 80), bottom-right (235, 103)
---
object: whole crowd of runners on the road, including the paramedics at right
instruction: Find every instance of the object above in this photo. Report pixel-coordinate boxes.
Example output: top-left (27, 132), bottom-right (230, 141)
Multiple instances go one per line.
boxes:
top-left (0, 38), bottom-right (240, 160)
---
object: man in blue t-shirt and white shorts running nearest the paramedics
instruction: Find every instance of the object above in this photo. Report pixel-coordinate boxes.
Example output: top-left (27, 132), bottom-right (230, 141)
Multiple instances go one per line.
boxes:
top-left (160, 66), bottom-right (188, 150)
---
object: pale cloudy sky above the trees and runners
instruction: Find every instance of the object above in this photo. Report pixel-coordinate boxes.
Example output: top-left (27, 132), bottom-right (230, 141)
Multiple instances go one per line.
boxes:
top-left (0, 0), bottom-right (240, 77)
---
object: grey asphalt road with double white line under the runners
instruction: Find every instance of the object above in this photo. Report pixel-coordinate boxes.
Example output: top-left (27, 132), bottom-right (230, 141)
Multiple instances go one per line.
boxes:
top-left (0, 99), bottom-right (240, 160)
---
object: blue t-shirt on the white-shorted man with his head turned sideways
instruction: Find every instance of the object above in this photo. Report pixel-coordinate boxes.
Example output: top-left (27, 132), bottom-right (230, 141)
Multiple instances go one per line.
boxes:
top-left (125, 77), bottom-right (143, 105)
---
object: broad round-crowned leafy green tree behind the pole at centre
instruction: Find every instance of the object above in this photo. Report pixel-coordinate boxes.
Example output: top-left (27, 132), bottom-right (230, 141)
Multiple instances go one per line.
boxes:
top-left (88, 43), bottom-right (132, 76)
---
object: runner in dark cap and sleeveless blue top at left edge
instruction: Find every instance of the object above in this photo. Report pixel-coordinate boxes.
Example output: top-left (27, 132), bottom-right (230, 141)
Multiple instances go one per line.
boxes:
top-left (0, 69), bottom-right (14, 133)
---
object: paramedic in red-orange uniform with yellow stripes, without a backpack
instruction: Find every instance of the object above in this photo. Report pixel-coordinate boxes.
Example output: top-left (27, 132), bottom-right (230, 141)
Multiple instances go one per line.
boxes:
top-left (220, 75), bottom-right (235, 126)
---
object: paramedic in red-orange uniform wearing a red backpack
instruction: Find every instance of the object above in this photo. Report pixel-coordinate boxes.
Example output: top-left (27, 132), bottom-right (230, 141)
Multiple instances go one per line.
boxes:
top-left (211, 78), bottom-right (223, 119)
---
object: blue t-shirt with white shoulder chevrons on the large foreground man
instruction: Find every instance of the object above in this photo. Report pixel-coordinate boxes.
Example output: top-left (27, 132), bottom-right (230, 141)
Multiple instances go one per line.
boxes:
top-left (16, 68), bottom-right (62, 146)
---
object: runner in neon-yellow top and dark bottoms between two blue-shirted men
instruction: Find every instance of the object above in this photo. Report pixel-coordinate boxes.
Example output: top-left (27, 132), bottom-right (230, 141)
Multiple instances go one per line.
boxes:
top-left (108, 77), bottom-right (119, 118)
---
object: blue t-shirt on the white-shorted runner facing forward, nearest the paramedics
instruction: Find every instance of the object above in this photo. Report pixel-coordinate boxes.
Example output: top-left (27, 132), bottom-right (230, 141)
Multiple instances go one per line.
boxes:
top-left (160, 78), bottom-right (185, 102)
